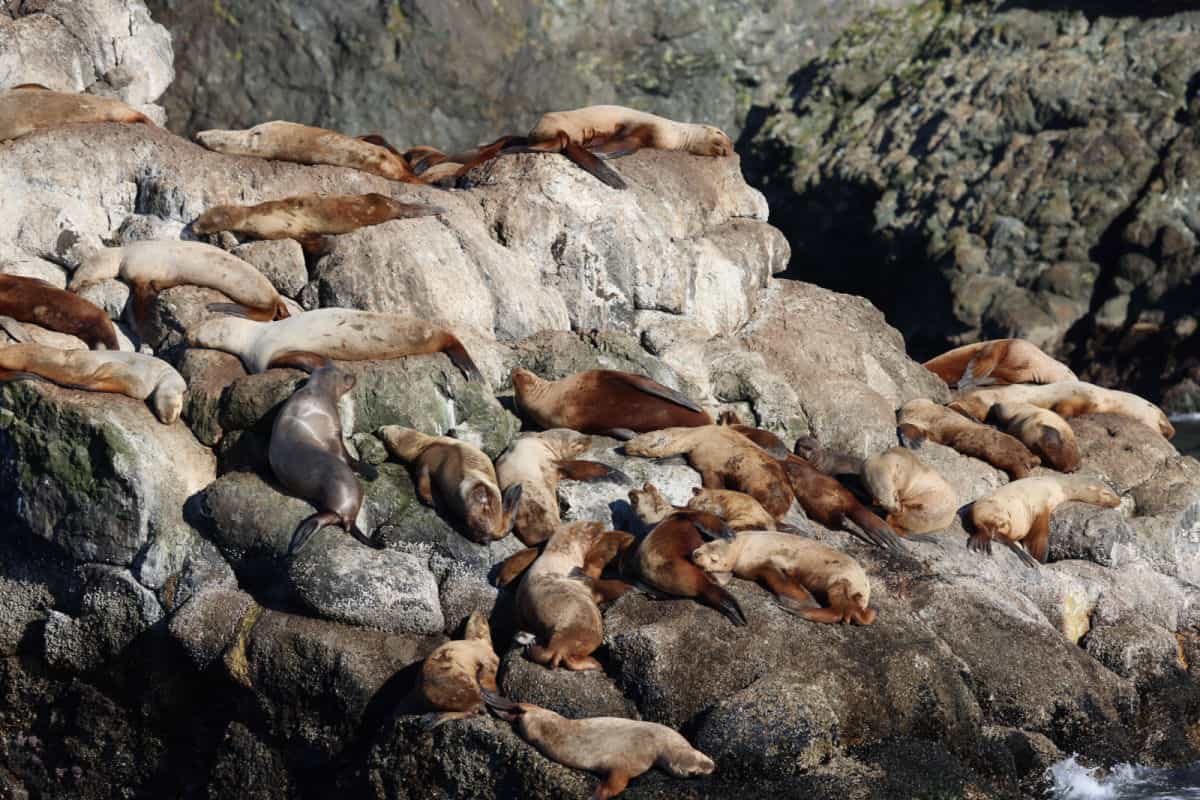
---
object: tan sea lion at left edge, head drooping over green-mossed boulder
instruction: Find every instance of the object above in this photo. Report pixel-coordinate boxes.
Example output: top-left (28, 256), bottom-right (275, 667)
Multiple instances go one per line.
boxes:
top-left (0, 343), bottom-right (187, 425)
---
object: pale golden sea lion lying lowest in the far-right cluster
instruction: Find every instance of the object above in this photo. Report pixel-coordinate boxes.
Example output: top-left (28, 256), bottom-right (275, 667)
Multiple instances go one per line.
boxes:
top-left (967, 475), bottom-right (1121, 566)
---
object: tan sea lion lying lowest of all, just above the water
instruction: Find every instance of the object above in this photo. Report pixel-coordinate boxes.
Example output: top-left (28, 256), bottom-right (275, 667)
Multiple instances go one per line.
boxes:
top-left (484, 692), bottom-right (716, 800)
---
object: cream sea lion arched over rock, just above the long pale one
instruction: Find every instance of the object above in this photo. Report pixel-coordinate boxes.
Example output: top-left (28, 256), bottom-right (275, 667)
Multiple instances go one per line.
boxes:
top-left (70, 241), bottom-right (288, 335)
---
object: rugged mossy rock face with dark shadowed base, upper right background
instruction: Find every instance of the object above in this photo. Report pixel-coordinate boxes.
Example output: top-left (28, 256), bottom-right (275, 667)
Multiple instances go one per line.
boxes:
top-left (748, 2), bottom-right (1200, 409)
